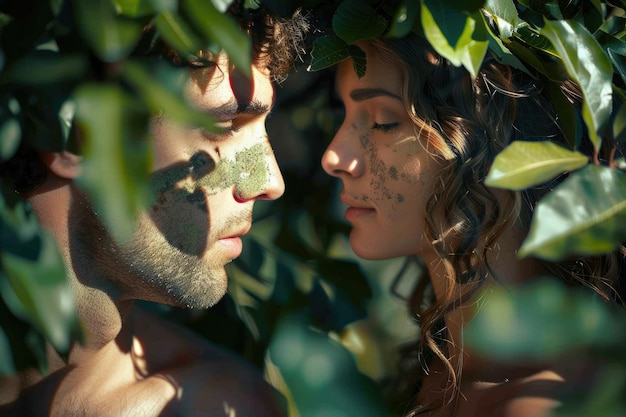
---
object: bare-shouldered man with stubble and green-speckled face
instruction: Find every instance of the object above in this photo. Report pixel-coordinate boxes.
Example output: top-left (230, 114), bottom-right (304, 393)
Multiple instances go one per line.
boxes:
top-left (0, 1), bottom-right (302, 417)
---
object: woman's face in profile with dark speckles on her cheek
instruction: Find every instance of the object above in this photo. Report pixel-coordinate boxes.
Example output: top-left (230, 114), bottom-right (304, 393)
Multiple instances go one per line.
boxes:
top-left (322, 44), bottom-right (442, 259)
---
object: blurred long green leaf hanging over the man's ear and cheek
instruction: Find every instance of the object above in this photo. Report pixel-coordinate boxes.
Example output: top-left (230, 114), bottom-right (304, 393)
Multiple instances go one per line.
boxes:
top-left (75, 84), bottom-right (151, 241)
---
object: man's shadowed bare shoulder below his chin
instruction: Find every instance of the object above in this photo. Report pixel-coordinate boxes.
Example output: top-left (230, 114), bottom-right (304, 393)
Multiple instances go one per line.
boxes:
top-left (133, 309), bottom-right (284, 417)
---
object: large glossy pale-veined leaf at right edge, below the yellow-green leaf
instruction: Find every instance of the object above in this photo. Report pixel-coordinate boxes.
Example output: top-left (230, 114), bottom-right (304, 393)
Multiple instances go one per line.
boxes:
top-left (519, 165), bottom-right (626, 260)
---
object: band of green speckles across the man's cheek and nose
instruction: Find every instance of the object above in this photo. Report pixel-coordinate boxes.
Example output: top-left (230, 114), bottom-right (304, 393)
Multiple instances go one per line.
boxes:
top-left (152, 142), bottom-right (273, 197)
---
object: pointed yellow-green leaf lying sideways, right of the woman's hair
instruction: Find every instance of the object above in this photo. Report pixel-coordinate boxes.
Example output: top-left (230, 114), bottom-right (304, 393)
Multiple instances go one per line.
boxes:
top-left (485, 141), bottom-right (589, 190)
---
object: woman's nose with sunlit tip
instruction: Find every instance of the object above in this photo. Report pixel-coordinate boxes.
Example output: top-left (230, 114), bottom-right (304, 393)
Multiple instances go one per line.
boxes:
top-left (322, 126), bottom-right (365, 178)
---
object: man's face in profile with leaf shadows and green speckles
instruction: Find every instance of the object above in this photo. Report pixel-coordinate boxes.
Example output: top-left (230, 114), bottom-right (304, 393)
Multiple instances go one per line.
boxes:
top-left (85, 56), bottom-right (284, 307)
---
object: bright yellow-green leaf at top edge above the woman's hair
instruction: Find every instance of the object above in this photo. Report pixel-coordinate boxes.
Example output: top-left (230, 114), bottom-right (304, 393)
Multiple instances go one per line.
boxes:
top-left (421, 0), bottom-right (489, 76)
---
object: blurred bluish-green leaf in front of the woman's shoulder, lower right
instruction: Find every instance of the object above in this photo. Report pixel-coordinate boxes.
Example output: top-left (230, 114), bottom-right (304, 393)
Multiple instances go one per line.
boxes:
top-left (464, 279), bottom-right (618, 361)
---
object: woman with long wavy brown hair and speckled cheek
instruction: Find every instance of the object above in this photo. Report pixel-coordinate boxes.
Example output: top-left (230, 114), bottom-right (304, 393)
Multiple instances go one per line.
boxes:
top-left (322, 36), bottom-right (619, 417)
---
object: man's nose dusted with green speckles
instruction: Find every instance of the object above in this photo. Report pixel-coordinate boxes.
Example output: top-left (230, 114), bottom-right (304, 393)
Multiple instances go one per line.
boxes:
top-left (235, 138), bottom-right (285, 201)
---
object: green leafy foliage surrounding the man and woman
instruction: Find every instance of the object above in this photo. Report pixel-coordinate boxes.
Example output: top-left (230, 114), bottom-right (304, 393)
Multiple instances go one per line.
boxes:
top-left (0, 0), bottom-right (626, 416)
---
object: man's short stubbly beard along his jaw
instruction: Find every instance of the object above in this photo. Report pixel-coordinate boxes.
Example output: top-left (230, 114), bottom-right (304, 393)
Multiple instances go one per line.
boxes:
top-left (70, 187), bottom-right (246, 308)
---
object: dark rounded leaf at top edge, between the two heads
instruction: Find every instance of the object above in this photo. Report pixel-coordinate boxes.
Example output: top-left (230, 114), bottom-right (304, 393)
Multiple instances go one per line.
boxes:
top-left (333, 0), bottom-right (387, 44)
